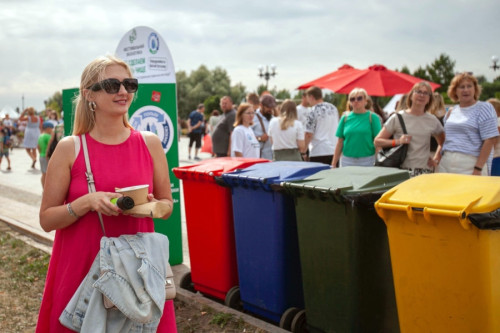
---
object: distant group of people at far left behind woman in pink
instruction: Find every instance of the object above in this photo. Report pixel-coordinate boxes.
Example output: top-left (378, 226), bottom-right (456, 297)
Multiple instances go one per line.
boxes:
top-left (0, 107), bottom-right (64, 183)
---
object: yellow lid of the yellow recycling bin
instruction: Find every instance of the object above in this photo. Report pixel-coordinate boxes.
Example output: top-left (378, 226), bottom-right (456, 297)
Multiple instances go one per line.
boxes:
top-left (375, 173), bottom-right (500, 228)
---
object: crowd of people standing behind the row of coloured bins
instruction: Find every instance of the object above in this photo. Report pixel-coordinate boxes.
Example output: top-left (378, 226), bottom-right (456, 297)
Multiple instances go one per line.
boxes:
top-left (195, 73), bottom-right (500, 177)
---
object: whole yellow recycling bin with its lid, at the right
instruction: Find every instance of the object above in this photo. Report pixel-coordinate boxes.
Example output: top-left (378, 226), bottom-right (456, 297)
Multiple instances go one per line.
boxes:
top-left (375, 174), bottom-right (500, 333)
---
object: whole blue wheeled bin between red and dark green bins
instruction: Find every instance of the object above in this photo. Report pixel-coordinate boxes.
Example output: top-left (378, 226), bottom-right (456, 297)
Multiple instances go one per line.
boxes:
top-left (222, 161), bottom-right (330, 329)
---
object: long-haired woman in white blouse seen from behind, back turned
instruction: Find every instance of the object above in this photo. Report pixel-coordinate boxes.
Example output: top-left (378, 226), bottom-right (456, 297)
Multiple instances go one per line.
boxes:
top-left (268, 99), bottom-right (306, 161)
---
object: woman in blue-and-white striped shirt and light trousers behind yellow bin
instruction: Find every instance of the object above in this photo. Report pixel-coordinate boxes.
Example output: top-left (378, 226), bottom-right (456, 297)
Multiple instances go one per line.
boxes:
top-left (438, 73), bottom-right (498, 176)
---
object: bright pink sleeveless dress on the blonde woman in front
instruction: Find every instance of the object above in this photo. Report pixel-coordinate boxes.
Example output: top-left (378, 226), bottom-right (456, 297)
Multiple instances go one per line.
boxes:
top-left (36, 130), bottom-right (177, 333)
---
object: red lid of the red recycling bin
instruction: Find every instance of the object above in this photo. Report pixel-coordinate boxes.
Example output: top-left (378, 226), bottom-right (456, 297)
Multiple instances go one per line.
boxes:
top-left (172, 157), bottom-right (270, 179)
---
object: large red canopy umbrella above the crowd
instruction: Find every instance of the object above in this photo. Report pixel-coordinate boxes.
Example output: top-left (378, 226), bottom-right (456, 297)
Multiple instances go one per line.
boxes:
top-left (299, 65), bottom-right (440, 96)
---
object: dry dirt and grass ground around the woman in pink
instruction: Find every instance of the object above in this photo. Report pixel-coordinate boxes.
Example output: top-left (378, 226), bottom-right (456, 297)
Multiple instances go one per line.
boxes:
top-left (0, 223), bottom-right (265, 333)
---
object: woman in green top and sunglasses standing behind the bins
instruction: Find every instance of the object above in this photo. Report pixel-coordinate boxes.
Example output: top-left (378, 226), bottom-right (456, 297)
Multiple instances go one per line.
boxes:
top-left (332, 88), bottom-right (382, 168)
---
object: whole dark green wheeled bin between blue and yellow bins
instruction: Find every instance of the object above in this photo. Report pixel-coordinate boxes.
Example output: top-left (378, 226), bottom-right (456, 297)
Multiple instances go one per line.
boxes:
top-left (281, 167), bottom-right (409, 333)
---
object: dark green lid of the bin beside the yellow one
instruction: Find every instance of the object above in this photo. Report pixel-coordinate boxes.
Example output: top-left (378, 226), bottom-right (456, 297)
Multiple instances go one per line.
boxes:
top-left (282, 166), bottom-right (410, 199)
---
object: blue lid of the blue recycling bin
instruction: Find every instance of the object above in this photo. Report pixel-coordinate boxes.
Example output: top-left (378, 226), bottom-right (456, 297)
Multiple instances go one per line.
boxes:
top-left (222, 161), bottom-right (330, 190)
